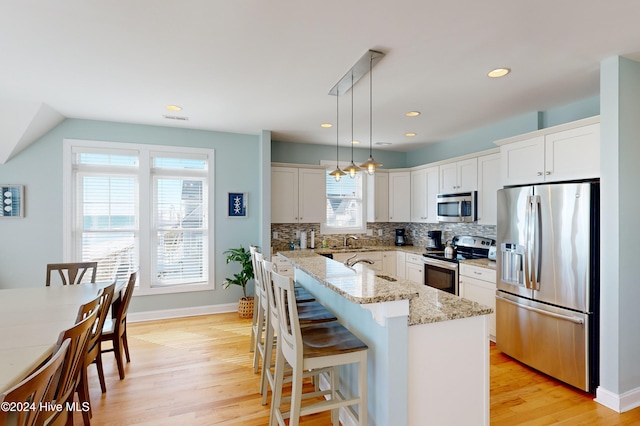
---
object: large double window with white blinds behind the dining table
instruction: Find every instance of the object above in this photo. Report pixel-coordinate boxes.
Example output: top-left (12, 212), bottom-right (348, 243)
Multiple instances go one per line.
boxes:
top-left (64, 141), bottom-right (214, 294)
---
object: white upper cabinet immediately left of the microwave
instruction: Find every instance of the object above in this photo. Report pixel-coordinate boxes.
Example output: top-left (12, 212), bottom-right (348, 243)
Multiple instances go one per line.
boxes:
top-left (411, 167), bottom-right (439, 223)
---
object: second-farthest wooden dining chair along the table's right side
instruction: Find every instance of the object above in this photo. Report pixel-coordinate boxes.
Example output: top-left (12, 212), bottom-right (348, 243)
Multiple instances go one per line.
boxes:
top-left (77, 281), bottom-right (116, 425)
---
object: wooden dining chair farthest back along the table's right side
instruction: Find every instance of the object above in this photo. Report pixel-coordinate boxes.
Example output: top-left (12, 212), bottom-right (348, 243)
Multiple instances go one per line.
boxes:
top-left (100, 272), bottom-right (138, 380)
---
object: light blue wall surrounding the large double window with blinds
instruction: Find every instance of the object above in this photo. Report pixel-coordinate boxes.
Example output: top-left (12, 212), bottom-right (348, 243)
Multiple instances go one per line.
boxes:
top-left (0, 119), bottom-right (268, 311)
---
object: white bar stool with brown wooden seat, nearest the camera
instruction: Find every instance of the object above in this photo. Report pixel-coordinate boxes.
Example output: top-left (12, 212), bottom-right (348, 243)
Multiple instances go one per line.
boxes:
top-left (271, 272), bottom-right (368, 426)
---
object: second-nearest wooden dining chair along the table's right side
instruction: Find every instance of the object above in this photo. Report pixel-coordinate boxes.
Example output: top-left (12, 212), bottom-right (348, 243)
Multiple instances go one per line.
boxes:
top-left (38, 310), bottom-right (98, 426)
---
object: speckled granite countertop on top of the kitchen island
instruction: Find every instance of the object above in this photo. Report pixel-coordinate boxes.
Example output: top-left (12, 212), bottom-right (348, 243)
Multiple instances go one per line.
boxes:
top-left (280, 250), bottom-right (493, 326)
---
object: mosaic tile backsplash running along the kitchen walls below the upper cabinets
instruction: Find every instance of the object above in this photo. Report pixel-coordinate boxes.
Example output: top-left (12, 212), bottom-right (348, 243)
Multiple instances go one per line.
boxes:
top-left (271, 222), bottom-right (496, 250)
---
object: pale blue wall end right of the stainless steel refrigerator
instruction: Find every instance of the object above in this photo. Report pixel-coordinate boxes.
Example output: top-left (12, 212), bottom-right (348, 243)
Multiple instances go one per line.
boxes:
top-left (598, 57), bottom-right (640, 400)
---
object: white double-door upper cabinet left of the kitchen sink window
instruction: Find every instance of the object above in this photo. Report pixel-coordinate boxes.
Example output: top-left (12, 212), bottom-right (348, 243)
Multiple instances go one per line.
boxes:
top-left (271, 167), bottom-right (327, 223)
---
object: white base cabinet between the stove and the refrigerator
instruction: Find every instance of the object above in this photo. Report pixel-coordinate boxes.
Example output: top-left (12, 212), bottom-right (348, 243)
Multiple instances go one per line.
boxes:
top-left (459, 262), bottom-right (496, 342)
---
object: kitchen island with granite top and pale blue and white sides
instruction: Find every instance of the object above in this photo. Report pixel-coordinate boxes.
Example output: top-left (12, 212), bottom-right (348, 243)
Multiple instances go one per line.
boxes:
top-left (280, 250), bottom-right (492, 425)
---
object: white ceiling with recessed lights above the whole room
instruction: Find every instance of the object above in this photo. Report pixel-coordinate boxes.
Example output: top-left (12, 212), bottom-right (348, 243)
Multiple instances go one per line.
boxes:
top-left (0, 0), bottom-right (640, 160)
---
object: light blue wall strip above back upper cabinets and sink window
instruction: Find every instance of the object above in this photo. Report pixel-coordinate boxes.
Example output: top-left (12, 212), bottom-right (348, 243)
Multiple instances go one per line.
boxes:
top-left (271, 141), bottom-right (407, 169)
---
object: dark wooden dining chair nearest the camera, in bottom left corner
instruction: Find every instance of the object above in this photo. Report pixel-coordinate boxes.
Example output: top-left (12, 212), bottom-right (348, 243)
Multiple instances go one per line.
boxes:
top-left (0, 340), bottom-right (71, 426)
